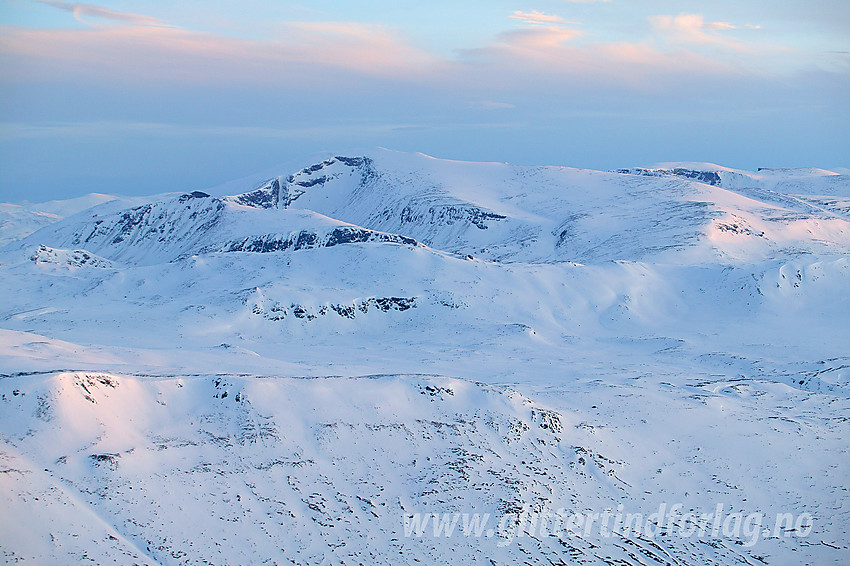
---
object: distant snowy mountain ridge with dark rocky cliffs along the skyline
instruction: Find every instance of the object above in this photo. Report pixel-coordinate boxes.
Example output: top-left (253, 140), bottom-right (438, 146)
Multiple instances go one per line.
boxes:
top-left (8, 151), bottom-right (850, 264)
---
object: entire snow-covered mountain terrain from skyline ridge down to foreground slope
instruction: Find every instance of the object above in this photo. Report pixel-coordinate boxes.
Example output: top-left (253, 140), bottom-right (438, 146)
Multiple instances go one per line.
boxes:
top-left (0, 150), bottom-right (850, 564)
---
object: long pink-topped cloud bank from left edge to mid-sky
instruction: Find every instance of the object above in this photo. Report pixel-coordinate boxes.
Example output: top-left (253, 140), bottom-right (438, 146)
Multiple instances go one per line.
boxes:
top-left (0, 22), bottom-right (436, 84)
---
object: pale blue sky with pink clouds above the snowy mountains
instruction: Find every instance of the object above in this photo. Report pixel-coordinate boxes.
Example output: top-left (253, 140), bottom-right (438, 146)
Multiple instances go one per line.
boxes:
top-left (0, 0), bottom-right (850, 202)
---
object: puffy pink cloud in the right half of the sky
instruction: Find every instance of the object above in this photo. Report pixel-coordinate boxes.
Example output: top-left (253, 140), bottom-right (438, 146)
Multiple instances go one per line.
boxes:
top-left (459, 11), bottom-right (779, 85)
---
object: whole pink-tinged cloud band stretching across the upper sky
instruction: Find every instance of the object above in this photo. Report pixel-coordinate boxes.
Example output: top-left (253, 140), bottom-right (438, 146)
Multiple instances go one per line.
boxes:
top-left (0, 8), bottom-right (788, 96)
